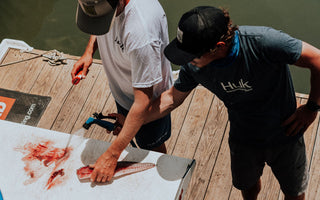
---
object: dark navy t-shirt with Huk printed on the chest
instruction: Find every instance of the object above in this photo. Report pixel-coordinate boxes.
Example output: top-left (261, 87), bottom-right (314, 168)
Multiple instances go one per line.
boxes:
top-left (174, 26), bottom-right (302, 146)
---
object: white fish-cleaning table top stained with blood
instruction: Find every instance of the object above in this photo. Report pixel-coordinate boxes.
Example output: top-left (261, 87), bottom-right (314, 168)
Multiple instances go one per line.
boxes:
top-left (0, 120), bottom-right (191, 200)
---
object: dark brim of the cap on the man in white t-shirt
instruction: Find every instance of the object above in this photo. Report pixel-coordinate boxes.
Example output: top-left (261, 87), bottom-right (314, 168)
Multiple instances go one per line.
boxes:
top-left (76, 3), bottom-right (115, 35)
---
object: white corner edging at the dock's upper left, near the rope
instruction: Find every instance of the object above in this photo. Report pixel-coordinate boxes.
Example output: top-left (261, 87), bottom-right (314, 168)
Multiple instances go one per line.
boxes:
top-left (0, 39), bottom-right (33, 61)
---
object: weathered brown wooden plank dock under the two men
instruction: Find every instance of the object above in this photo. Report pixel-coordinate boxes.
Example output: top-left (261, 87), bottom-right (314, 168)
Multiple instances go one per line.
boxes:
top-left (0, 49), bottom-right (320, 200)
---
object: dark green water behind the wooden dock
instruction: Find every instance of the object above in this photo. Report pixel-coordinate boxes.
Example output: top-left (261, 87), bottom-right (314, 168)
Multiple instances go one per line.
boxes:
top-left (0, 0), bottom-right (320, 93)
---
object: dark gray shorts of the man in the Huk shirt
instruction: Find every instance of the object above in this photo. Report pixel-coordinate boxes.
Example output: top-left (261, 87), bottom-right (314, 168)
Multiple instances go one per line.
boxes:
top-left (229, 137), bottom-right (309, 196)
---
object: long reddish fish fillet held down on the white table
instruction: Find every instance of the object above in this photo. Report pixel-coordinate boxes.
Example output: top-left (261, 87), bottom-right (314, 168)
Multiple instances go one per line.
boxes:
top-left (77, 161), bottom-right (155, 180)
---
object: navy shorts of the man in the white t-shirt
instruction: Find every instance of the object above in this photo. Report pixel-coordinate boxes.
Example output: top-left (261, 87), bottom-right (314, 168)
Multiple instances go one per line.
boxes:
top-left (116, 102), bottom-right (171, 150)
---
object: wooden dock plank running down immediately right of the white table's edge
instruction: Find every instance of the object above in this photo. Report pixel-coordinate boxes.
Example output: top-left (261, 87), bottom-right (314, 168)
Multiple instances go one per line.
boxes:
top-left (186, 98), bottom-right (229, 199)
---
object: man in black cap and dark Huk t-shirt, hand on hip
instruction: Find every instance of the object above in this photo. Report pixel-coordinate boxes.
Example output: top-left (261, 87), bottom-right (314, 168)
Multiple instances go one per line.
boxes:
top-left (141, 6), bottom-right (320, 199)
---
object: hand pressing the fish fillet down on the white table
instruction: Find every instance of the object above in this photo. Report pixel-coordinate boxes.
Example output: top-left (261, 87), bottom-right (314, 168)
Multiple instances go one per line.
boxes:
top-left (90, 150), bottom-right (118, 183)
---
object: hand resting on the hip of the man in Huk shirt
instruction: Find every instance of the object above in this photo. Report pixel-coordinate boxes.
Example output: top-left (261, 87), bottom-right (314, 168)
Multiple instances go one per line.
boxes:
top-left (282, 105), bottom-right (318, 136)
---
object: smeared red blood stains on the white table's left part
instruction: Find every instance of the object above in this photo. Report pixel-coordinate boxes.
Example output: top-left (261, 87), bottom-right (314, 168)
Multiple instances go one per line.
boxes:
top-left (15, 141), bottom-right (72, 190)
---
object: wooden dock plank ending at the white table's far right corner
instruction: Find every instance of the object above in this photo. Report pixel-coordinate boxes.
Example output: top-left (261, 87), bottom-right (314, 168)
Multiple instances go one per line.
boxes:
top-left (173, 87), bottom-right (213, 158)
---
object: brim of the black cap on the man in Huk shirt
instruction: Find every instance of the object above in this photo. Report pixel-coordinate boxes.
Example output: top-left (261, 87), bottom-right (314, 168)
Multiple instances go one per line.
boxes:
top-left (164, 38), bottom-right (197, 65)
